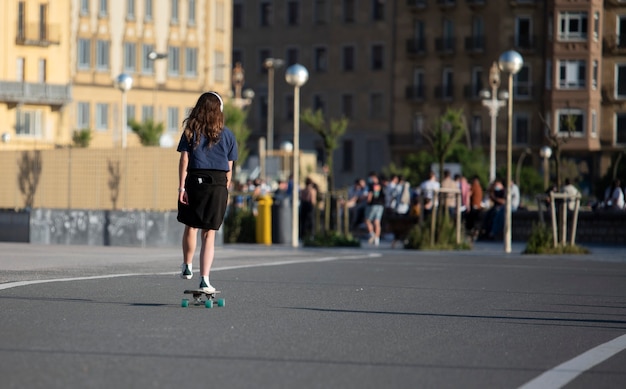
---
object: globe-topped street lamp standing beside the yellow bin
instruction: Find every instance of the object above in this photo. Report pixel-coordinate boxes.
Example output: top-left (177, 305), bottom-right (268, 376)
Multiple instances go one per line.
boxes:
top-left (285, 64), bottom-right (309, 247)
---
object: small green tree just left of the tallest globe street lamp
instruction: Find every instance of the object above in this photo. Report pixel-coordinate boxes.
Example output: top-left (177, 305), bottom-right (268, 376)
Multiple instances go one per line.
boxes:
top-left (424, 108), bottom-right (466, 179)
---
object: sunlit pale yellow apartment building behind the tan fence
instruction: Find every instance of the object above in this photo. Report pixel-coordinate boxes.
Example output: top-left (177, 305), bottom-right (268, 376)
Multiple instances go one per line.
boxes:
top-left (0, 0), bottom-right (232, 149)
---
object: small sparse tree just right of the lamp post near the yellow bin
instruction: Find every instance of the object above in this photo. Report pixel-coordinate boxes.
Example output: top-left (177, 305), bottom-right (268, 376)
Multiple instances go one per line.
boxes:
top-left (300, 108), bottom-right (348, 191)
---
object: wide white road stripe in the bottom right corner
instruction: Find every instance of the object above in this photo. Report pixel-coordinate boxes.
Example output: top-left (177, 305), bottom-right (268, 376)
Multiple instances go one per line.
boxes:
top-left (519, 335), bottom-right (626, 389)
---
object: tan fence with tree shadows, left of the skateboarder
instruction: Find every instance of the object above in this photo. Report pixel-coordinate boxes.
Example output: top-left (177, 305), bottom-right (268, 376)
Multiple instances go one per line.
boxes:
top-left (0, 147), bottom-right (179, 211)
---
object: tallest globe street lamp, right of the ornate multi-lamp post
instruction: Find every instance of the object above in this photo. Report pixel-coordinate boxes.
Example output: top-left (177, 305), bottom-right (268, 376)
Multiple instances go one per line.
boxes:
top-left (498, 50), bottom-right (524, 253)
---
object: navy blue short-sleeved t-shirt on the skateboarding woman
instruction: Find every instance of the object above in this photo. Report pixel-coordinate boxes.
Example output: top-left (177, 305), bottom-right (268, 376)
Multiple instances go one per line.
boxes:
top-left (176, 127), bottom-right (237, 172)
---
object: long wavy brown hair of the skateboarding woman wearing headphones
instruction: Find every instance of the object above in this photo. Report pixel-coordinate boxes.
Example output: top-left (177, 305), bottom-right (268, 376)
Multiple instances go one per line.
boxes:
top-left (183, 92), bottom-right (224, 148)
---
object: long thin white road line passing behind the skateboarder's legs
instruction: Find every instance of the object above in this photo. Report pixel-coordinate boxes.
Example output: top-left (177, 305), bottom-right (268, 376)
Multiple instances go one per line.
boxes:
top-left (0, 253), bottom-right (381, 290)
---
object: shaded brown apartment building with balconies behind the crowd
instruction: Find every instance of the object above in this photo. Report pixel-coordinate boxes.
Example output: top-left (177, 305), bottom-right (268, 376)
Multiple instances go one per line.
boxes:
top-left (233, 0), bottom-right (626, 191)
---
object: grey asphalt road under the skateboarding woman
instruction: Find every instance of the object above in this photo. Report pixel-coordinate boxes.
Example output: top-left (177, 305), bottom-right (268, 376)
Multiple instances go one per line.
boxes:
top-left (0, 243), bottom-right (626, 389)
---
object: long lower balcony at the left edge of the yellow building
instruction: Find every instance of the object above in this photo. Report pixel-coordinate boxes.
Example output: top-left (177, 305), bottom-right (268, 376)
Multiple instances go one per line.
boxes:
top-left (0, 81), bottom-right (72, 106)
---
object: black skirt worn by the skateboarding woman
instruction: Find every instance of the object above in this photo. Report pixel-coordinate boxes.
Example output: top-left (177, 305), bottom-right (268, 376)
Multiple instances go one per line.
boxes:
top-left (177, 170), bottom-right (228, 230)
